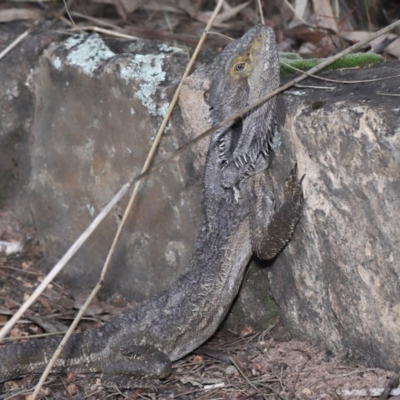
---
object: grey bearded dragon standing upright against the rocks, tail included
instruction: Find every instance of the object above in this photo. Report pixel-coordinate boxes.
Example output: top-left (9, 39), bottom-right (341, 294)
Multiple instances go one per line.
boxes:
top-left (0, 25), bottom-right (303, 388)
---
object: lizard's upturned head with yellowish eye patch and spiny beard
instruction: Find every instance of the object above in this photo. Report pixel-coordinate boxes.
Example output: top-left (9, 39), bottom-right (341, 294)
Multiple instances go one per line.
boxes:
top-left (209, 25), bottom-right (280, 187)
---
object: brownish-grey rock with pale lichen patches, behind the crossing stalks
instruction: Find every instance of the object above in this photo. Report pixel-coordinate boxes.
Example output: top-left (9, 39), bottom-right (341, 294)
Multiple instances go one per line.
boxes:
top-left (29, 35), bottom-right (202, 301)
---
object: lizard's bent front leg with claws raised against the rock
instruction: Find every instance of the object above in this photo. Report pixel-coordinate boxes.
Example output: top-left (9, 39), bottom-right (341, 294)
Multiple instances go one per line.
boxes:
top-left (249, 166), bottom-right (304, 260)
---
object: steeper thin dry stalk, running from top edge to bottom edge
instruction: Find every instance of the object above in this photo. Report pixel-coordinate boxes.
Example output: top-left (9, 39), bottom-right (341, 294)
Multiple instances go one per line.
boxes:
top-left (32, 0), bottom-right (224, 400)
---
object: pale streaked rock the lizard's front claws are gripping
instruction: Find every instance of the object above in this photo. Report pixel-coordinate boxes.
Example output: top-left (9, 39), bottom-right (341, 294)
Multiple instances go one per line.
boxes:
top-left (268, 63), bottom-right (400, 369)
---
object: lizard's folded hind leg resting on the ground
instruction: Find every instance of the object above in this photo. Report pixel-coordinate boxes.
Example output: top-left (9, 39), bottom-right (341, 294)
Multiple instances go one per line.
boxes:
top-left (101, 345), bottom-right (172, 390)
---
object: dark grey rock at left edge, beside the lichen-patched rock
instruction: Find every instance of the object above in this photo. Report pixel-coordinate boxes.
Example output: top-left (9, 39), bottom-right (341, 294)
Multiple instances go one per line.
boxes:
top-left (0, 22), bottom-right (60, 219)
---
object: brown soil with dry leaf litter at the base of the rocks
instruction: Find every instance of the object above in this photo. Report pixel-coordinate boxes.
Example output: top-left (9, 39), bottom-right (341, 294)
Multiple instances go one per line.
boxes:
top-left (0, 211), bottom-right (398, 400)
